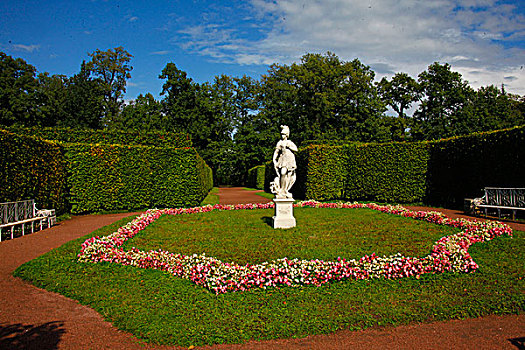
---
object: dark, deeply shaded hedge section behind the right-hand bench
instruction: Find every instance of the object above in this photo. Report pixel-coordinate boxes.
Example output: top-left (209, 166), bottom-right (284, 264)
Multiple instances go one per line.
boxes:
top-left (425, 126), bottom-right (525, 208)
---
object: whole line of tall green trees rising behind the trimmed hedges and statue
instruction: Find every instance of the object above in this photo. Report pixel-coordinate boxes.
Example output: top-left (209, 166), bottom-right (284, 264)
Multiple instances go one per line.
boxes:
top-left (0, 51), bottom-right (525, 184)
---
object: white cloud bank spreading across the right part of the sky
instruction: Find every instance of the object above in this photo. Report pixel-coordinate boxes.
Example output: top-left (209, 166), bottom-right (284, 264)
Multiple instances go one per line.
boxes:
top-left (176, 0), bottom-right (525, 94)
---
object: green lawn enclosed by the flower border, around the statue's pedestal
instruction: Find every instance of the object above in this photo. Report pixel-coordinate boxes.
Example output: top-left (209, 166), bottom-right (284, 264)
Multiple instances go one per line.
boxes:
top-left (124, 208), bottom-right (459, 265)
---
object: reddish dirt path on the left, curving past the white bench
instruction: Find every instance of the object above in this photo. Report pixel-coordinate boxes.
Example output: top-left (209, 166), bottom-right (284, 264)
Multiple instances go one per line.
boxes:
top-left (0, 214), bottom-right (173, 349)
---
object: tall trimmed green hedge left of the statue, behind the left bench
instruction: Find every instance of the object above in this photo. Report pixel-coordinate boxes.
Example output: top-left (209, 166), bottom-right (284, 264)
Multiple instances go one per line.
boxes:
top-left (0, 130), bottom-right (213, 214)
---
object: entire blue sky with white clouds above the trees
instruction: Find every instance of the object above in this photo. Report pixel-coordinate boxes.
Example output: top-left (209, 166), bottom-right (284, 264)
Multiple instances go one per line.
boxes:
top-left (0, 0), bottom-right (525, 99)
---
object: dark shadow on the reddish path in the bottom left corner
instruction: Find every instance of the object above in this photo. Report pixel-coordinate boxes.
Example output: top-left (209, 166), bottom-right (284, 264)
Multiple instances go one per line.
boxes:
top-left (0, 322), bottom-right (66, 350)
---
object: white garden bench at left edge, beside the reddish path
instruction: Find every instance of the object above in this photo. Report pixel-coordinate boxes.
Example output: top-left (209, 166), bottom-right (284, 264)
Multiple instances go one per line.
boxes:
top-left (0, 199), bottom-right (56, 242)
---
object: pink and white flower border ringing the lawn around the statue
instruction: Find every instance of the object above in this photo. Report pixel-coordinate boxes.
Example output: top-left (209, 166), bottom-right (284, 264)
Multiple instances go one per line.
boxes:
top-left (78, 201), bottom-right (512, 294)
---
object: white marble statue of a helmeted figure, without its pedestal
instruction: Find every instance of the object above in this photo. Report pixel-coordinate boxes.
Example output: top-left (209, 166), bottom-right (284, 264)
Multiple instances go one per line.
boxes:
top-left (270, 125), bottom-right (297, 199)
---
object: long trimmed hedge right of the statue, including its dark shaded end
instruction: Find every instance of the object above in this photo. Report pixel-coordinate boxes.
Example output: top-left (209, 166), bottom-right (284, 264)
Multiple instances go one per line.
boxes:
top-left (292, 126), bottom-right (525, 208)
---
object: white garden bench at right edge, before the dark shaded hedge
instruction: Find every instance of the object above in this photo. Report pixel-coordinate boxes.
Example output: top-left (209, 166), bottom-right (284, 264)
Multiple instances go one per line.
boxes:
top-left (473, 187), bottom-right (525, 220)
